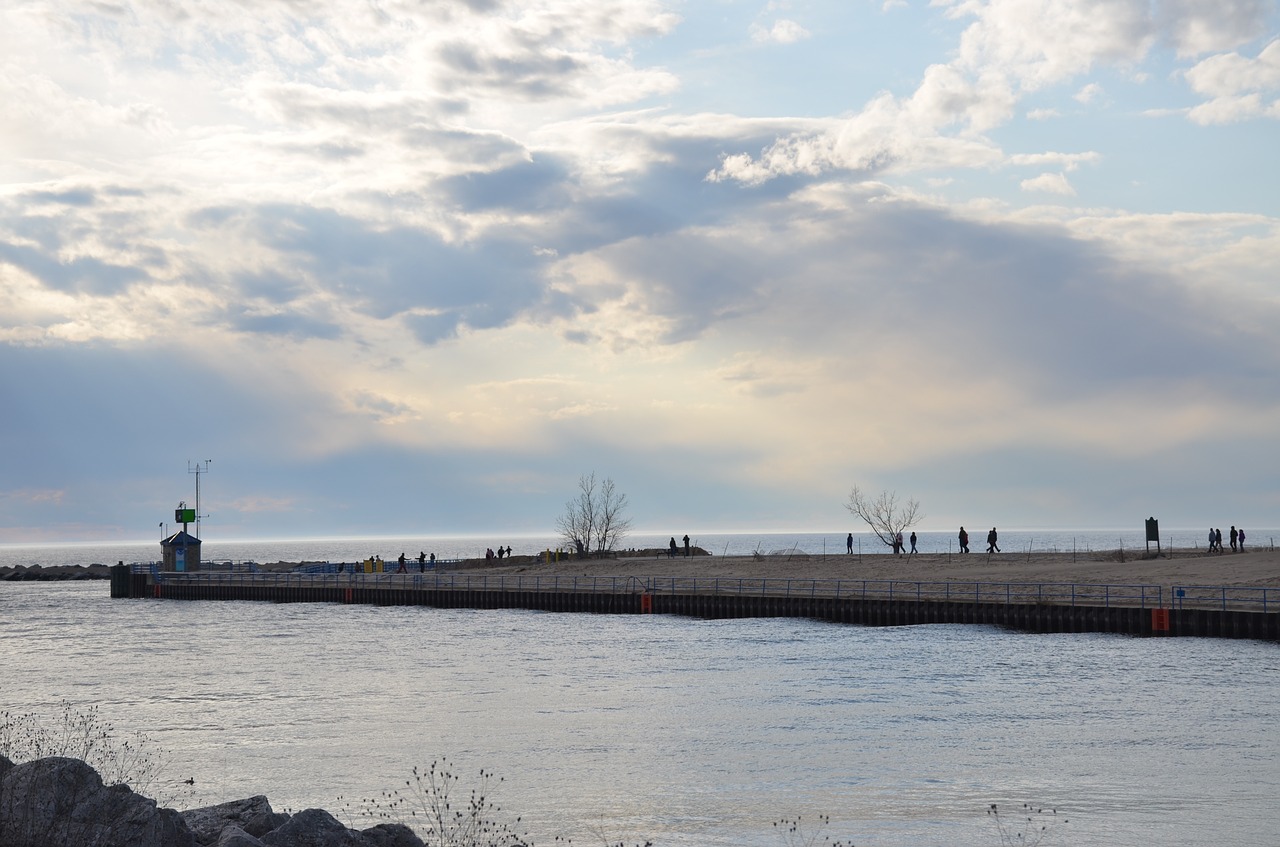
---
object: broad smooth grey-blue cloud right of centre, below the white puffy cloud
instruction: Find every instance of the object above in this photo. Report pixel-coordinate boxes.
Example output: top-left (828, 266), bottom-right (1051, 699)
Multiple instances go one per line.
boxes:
top-left (588, 190), bottom-right (1280, 397)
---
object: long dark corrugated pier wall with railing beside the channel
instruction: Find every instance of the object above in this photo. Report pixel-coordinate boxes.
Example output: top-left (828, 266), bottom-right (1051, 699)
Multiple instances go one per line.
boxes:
top-left (111, 566), bottom-right (1280, 641)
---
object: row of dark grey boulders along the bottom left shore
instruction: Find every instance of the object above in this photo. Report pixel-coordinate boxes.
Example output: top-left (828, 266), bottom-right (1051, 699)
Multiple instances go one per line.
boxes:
top-left (0, 756), bottom-right (425, 847)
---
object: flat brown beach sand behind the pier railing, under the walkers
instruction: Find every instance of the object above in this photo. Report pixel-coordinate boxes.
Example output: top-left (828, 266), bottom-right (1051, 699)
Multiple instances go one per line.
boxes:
top-left (466, 548), bottom-right (1280, 587)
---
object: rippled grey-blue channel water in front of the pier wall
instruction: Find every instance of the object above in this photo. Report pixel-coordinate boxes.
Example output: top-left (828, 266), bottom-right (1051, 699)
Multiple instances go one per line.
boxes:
top-left (0, 583), bottom-right (1280, 847)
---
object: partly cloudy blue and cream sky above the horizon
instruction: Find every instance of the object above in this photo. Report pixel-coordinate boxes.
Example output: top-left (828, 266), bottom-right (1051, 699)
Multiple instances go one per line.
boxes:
top-left (0, 0), bottom-right (1280, 542)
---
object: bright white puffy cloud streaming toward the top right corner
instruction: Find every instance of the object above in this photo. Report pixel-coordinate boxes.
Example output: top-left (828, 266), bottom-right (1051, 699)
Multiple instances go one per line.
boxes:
top-left (708, 0), bottom-right (1274, 186)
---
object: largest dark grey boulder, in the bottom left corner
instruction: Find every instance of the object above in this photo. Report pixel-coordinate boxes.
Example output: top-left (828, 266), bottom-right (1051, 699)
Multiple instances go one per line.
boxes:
top-left (0, 756), bottom-right (196, 847)
